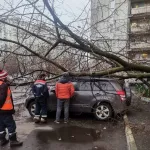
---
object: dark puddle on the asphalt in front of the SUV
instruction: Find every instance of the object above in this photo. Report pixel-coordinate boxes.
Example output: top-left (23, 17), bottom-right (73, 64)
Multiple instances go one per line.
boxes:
top-left (36, 126), bottom-right (101, 143)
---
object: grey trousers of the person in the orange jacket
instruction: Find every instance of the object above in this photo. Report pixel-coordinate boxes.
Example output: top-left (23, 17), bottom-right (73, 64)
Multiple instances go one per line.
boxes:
top-left (56, 99), bottom-right (69, 121)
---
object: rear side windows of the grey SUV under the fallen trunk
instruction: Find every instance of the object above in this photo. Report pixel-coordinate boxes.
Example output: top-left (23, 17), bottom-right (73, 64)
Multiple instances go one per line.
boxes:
top-left (79, 81), bottom-right (115, 91)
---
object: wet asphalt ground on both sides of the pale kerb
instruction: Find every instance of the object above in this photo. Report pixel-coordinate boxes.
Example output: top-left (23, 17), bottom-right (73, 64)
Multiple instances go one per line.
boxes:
top-left (0, 88), bottom-right (150, 150)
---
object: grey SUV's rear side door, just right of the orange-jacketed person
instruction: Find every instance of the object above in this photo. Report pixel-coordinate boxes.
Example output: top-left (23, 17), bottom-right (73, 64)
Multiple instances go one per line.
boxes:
top-left (70, 82), bottom-right (93, 112)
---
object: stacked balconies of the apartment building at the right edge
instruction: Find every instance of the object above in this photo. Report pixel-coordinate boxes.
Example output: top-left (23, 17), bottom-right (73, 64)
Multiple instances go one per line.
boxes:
top-left (128, 0), bottom-right (150, 64)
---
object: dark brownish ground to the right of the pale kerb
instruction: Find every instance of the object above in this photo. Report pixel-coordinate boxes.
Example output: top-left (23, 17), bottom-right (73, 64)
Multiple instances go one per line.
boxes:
top-left (128, 96), bottom-right (150, 150)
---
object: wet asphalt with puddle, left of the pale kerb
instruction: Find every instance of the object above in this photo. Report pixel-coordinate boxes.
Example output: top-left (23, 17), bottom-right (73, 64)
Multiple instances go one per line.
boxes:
top-left (1, 111), bottom-right (127, 150)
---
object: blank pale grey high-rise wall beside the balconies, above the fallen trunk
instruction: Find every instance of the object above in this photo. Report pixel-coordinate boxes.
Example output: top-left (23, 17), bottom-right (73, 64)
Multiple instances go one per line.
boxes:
top-left (91, 0), bottom-right (128, 53)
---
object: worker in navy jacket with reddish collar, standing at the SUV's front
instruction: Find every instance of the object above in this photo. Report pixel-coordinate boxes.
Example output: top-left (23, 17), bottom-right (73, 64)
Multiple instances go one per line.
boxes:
top-left (32, 74), bottom-right (49, 123)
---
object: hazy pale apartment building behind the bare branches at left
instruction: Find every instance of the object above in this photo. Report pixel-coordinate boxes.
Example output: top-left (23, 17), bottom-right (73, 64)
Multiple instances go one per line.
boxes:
top-left (0, 17), bottom-right (51, 50)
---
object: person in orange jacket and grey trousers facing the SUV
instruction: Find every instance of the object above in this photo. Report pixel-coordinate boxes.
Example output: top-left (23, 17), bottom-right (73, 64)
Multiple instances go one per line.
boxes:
top-left (55, 73), bottom-right (74, 123)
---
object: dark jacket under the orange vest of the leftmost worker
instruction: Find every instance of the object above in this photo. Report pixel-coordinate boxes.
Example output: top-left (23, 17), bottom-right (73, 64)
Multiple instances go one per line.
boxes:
top-left (0, 82), bottom-right (15, 114)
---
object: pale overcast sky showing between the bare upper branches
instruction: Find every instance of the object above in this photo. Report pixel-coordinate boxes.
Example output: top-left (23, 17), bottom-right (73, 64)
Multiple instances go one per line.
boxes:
top-left (0, 0), bottom-right (90, 27)
